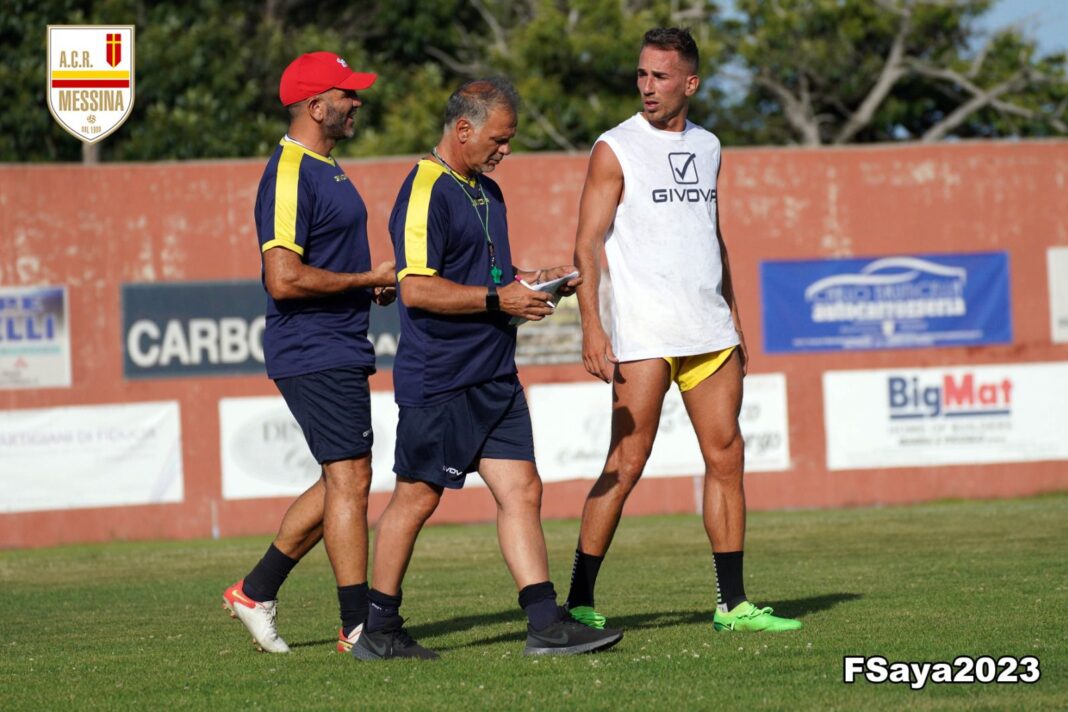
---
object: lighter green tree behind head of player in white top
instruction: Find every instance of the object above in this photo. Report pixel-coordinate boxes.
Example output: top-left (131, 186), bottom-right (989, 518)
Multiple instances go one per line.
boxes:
top-left (412, 0), bottom-right (724, 151)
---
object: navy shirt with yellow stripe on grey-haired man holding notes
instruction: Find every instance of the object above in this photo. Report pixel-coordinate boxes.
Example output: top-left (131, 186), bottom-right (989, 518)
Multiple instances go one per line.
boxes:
top-left (390, 160), bottom-right (516, 406)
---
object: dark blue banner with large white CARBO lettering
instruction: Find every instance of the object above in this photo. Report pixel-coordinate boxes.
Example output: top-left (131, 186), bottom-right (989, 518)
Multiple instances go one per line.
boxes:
top-left (123, 280), bottom-right (401, 378)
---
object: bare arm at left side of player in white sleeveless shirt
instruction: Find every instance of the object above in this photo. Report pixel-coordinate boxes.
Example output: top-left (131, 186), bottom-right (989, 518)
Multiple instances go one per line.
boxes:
top-left (575, 142), bottom-right (624, 382)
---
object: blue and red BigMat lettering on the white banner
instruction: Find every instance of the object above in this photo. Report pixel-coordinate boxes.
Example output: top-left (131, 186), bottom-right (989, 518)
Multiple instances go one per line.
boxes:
top-left (886, 374), bottom-right (1012, 421)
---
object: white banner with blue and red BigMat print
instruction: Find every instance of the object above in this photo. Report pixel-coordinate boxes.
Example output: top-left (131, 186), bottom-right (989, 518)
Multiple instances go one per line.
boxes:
top-left (823, 363), bottom-right (1068, 470)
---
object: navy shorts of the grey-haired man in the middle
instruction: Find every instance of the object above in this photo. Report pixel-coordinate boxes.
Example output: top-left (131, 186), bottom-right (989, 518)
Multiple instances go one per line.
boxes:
top-left (393, 376), bottom-right (534, 490)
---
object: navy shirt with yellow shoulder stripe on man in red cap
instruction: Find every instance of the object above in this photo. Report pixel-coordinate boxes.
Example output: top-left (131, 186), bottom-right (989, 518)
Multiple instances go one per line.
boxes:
top-left (255, 139), bottom-right (375, 379)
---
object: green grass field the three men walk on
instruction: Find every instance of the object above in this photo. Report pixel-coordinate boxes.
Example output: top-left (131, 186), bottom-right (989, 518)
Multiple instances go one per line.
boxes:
top-left (0, 495), bottom-right (1068, 711)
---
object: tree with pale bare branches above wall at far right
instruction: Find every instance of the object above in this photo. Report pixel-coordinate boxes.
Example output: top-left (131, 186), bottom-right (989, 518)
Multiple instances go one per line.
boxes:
top-left (716, 0), bottom-right (1068, 146)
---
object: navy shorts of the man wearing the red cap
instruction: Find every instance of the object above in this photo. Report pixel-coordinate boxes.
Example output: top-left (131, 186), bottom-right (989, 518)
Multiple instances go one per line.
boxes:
top-left (274, 366), bottom-right (375, 464)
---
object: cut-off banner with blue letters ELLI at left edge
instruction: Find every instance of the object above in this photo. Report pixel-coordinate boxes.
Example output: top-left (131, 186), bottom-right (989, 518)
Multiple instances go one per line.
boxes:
top-left (0, 287), bottom-right (70, 389)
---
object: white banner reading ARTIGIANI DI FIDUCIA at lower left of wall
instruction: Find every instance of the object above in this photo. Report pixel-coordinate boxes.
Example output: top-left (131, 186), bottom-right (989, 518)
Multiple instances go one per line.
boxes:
top-left (0, 400), bottom-right (183, 512)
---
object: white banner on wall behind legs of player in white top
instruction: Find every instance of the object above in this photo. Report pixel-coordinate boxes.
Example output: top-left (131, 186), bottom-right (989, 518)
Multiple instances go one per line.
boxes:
top-left (527, 374), bottom-right (790, 481)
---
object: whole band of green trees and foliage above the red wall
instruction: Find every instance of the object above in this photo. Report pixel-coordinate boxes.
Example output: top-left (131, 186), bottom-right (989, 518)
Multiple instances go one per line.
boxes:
top-left (0, 0), bottom-right (1068, 161)
